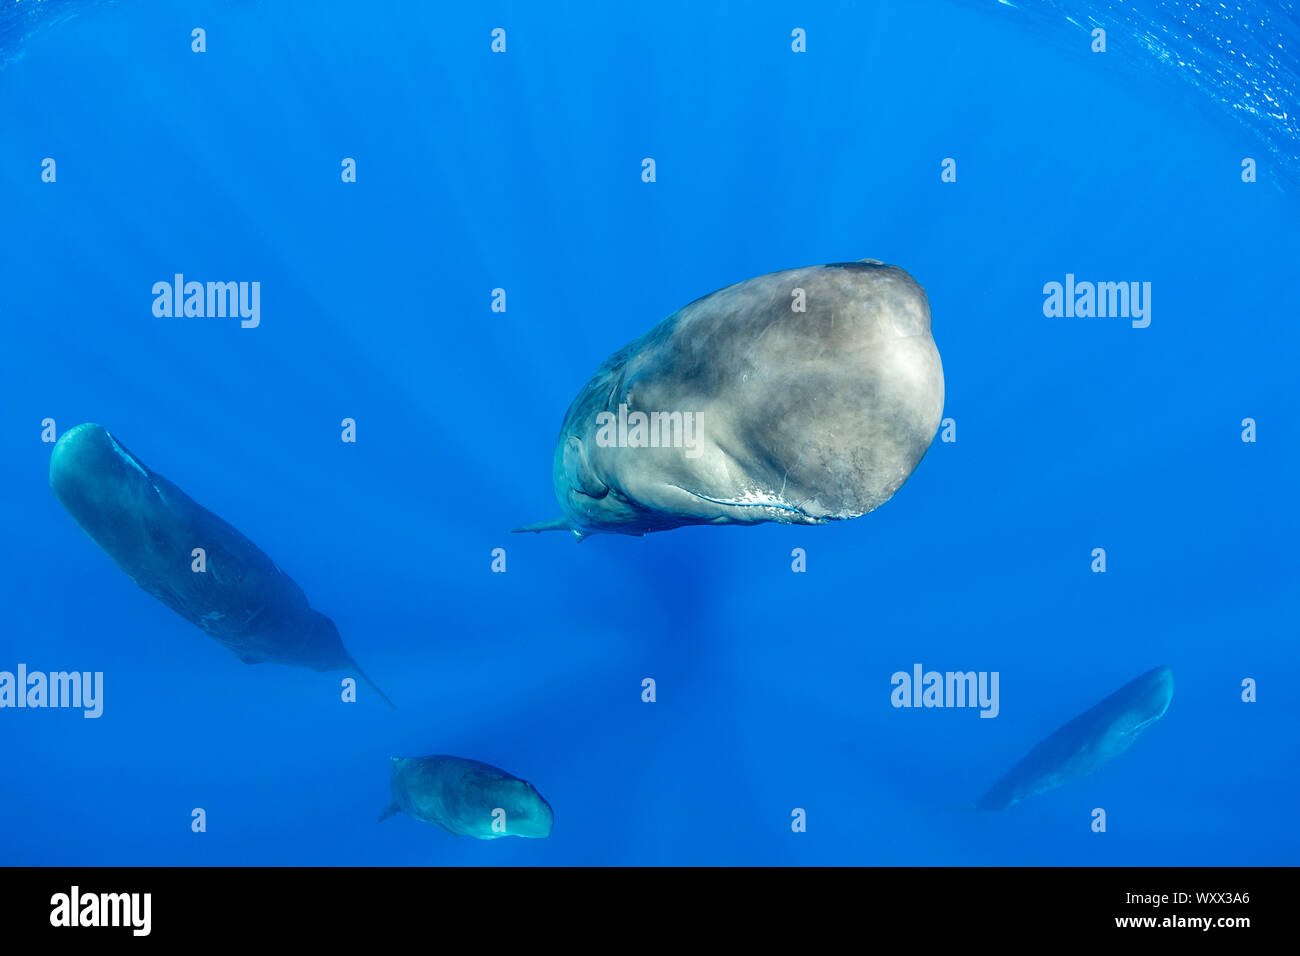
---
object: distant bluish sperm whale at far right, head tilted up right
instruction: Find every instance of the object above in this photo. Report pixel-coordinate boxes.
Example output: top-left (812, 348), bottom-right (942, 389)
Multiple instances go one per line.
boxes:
top-left (976, 667), bottom-right (1174, 810)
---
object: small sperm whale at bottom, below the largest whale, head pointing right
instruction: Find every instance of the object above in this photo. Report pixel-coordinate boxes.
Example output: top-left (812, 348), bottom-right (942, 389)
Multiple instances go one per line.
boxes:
top-left (380, 756), bottom-right (555, 840)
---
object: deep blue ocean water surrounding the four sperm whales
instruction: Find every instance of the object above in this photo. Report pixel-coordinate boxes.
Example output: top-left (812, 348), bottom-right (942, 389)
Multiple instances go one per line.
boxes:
top-left (0, 0), bottom-right (1300, 865)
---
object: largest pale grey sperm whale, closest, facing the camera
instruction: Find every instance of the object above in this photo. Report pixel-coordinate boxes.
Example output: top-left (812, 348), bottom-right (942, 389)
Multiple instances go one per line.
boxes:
top-left (516, 259), bottom-right (944, 541)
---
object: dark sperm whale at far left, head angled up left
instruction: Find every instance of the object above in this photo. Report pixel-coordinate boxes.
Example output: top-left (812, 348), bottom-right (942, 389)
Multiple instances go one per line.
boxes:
top-left (49, 424), bottom-right (393, 706)
